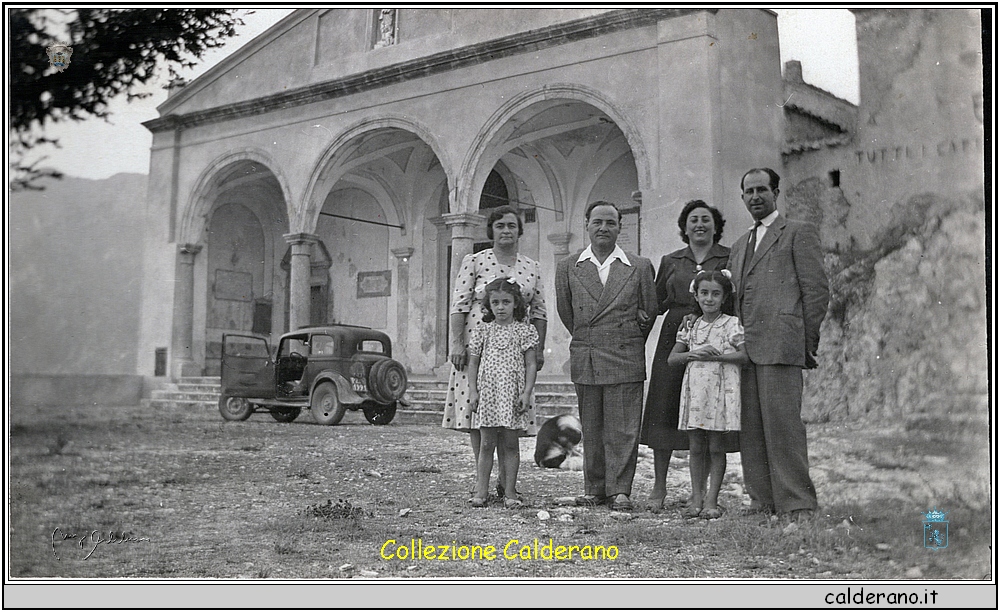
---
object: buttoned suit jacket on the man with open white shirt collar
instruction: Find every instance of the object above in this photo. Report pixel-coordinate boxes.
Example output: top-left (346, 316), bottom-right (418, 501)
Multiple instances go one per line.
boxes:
top-left (556, 250), bottom-right (658, 385)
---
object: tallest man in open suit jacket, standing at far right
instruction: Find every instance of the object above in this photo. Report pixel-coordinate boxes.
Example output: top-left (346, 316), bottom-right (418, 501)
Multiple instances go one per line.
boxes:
top-left (729, 168), bottom-right (830, 521)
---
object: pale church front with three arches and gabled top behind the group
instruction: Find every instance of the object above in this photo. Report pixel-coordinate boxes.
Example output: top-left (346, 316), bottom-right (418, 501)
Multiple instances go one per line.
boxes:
top-left (138, 8), bottom-right (785, 378)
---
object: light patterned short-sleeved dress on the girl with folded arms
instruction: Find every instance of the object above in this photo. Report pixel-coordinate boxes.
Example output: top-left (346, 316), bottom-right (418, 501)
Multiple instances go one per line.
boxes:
top-left (677, 314), bottom-right (743, 431)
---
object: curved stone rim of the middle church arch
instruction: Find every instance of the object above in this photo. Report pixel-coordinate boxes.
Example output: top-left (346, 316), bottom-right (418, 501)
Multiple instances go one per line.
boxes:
top-left (298, 115), bottom-right (454, 232)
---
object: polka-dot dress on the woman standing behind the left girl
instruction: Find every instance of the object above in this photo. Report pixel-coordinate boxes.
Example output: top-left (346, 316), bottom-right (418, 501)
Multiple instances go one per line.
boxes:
top-left (441, 249), bottom-right (546, 436)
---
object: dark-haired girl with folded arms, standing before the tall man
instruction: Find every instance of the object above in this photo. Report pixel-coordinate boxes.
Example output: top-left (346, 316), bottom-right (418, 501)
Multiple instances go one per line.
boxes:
top-left (667, 270), bottom-right (747, 519)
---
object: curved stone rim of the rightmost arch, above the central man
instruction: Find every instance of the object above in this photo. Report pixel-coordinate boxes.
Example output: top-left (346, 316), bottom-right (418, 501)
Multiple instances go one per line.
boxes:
top-left (458, 83), bottom-right (651, 212)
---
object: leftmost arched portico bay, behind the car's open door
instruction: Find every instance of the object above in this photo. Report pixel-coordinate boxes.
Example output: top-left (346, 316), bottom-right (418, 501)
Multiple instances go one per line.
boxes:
top-left (172, 149), bottom-right (290, 375)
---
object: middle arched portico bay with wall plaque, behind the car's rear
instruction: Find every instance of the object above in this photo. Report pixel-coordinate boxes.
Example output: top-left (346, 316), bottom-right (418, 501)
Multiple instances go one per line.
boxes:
top-left (289, 116), bottom-right (449, 370)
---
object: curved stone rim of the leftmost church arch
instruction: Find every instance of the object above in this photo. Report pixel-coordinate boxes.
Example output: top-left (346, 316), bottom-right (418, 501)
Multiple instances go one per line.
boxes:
top-left (177, 148), bottom-right (295, 244)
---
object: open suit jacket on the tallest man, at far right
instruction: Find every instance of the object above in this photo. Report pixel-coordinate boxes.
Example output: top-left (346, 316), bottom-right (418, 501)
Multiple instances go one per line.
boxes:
top-left (729, 214), bottom-right (830, 367)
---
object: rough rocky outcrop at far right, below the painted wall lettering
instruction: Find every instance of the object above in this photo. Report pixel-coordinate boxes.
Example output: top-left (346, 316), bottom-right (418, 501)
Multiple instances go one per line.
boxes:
top-left (804, 192), bottom-right (989, 424)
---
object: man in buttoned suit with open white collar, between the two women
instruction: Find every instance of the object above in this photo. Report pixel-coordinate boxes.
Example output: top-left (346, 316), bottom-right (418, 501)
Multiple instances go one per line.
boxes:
top-left (556, 201), bottom-right (657, 510)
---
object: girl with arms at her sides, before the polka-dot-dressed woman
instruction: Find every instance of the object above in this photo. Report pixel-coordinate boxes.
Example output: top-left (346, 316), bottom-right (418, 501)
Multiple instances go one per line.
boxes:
top-left (469, 278), bottom-right (538, 508)
